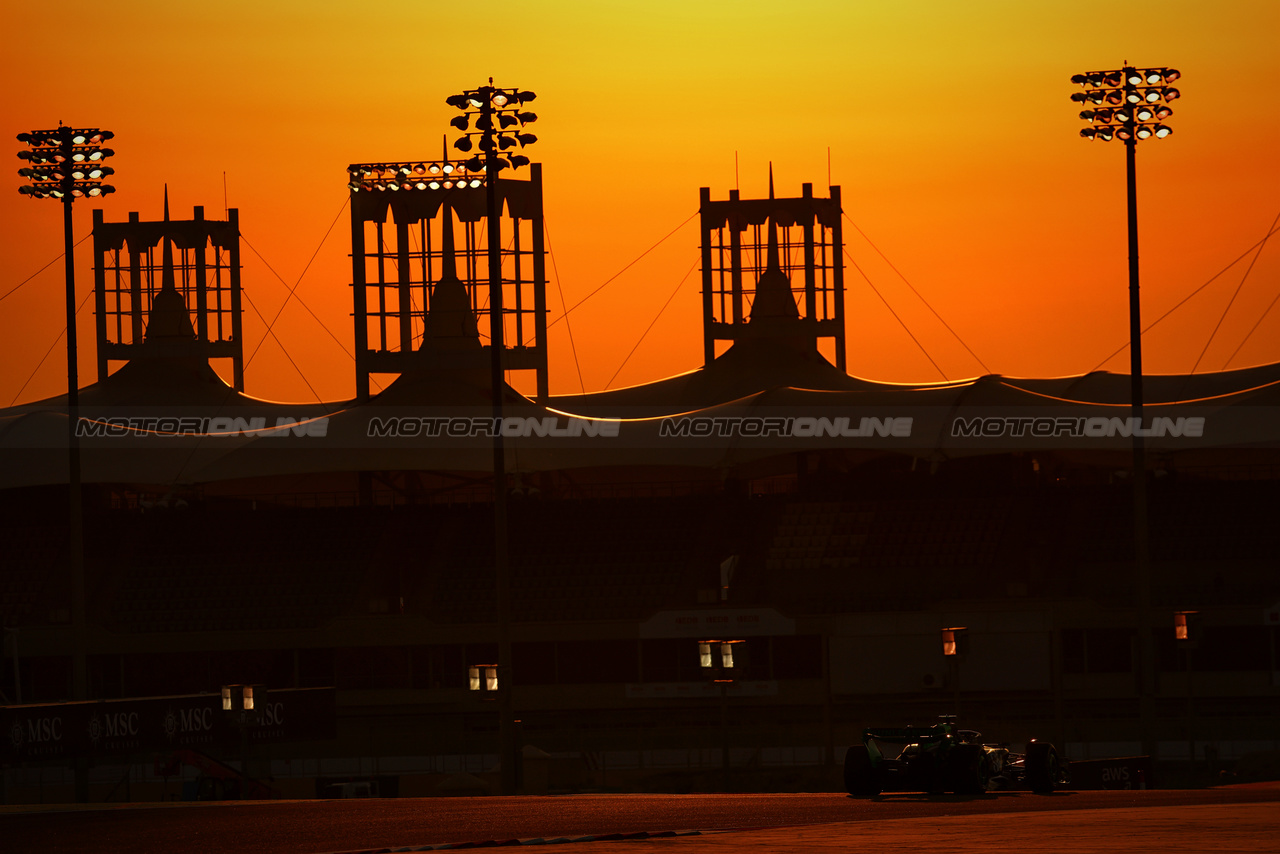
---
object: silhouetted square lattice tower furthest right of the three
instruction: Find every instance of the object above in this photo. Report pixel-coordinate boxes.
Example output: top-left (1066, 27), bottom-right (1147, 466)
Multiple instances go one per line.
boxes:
top-left (699, 179), bottom-right (845, 370)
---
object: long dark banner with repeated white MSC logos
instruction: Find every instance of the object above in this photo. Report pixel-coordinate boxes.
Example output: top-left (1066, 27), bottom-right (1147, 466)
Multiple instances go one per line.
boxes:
top-left (0, 688), bottom-right (337, 763)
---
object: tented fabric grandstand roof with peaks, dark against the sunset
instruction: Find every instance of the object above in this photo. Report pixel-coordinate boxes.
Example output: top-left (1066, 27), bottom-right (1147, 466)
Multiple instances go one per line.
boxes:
top-left (0, 353), bottom-right (1280, 488)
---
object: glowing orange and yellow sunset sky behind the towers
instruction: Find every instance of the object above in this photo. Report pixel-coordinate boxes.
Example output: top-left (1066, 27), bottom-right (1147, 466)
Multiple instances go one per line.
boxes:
top-left (0, 0), bottom-right (1280, 406)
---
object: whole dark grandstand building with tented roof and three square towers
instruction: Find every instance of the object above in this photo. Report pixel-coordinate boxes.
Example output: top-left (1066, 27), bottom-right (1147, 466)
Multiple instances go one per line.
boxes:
top-left (0, 172), bottom-right (1280, 800)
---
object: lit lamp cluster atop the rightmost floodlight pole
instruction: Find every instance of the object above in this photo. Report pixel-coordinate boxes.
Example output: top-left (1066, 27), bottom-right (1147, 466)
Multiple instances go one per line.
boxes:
top-left (1071, 68), bottom-right (1181, 142)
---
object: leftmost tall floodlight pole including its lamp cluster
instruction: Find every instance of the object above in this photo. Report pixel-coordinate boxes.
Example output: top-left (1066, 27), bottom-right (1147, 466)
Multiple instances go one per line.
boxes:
top-left (18, 124), bottom-right (115, 802)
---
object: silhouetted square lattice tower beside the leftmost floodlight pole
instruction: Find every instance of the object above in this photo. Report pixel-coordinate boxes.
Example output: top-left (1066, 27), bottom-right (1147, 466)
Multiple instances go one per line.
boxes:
top-left (93, 197), bottom-right (244, 392)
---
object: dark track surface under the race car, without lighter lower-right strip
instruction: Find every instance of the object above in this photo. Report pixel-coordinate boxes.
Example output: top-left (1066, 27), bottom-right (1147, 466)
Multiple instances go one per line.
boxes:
top-left (0, 787), bottom-right (1280, 854)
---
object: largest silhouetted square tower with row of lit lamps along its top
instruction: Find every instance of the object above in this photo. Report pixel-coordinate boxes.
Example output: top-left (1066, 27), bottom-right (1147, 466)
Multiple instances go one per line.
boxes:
top-left (348, 159), bottom-right (548, 399)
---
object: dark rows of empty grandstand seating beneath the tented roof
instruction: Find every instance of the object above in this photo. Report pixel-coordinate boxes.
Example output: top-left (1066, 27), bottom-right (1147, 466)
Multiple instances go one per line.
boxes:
top-left (0, 475), bottom-right (1277, 632)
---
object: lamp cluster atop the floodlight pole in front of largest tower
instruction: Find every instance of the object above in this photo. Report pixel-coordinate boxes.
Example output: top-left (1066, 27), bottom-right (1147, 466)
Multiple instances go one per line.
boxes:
top-left (444, 79), bottom-right (538, 173)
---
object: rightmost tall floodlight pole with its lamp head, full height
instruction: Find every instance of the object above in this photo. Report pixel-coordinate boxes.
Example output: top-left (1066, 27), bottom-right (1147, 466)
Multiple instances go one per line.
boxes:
top-left (1071, 65), bottom-right (1181, 755)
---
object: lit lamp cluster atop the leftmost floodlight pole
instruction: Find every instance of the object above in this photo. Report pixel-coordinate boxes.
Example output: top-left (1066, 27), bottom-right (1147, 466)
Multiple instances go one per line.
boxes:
top-left (18, 127), bottom-right (115, 198)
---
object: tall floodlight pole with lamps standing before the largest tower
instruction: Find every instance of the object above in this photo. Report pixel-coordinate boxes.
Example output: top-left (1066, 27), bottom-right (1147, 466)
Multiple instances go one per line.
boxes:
top-left (444, 77), bottom-right (538, 795)
